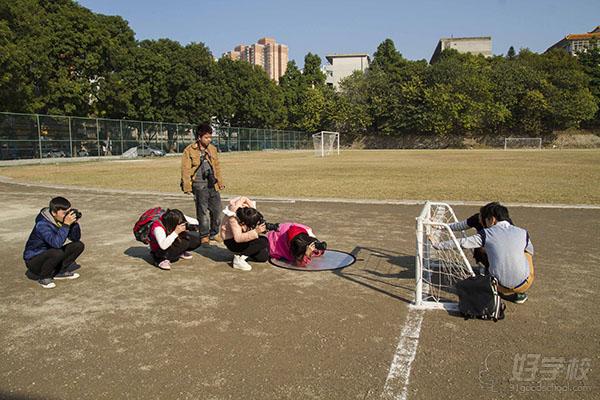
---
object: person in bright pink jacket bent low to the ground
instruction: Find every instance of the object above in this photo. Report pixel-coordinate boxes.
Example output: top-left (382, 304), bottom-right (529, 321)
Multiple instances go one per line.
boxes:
top-left (267, 222), bottom-right (327, 267)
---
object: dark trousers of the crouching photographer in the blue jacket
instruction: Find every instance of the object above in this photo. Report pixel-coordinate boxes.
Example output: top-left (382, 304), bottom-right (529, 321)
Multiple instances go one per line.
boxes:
top-left (25, 242), bottom-right (85, 279)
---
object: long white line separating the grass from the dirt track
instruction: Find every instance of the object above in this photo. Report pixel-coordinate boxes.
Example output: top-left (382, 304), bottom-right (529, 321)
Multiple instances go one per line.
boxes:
top-left (0, 175), bottom-right (600, 210)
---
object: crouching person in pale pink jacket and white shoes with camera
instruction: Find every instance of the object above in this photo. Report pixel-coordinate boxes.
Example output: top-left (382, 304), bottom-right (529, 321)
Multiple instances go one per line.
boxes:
top-left (220, 197), bottom-right (269, 271)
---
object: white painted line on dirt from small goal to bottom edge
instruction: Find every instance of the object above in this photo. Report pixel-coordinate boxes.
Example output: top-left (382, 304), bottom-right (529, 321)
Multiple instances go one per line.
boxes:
top-left (381, 307), bottom-right (423, 400)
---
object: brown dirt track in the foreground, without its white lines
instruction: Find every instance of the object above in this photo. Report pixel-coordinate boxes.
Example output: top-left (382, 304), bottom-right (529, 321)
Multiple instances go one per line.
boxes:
top-left (0, 183), bottom-right (600, 399)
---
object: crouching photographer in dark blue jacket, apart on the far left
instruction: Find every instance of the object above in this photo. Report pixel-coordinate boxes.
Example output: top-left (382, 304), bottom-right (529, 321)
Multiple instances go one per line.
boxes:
top-left (23, 197), bottom-right (84, 289)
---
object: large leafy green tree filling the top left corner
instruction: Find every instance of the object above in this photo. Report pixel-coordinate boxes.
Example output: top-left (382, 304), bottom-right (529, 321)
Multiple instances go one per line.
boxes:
top-left (0, 0), bottom-right (135, 115)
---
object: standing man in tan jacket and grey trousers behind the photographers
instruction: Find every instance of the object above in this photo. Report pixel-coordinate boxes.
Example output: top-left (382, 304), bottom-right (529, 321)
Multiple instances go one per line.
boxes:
top-left (181, 124), bottom-right (225, 244)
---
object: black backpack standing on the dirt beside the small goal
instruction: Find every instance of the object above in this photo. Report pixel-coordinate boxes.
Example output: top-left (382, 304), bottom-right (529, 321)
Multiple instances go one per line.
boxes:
top-left (456, 275), bottom-right (506, 322)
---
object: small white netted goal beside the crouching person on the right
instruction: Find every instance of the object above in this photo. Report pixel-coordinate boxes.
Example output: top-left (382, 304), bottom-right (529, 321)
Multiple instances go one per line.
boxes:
top-left (414, 201), bottom-right (474, 310)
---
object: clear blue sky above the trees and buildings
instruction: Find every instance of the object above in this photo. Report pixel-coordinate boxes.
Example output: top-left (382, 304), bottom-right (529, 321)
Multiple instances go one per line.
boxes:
top-left (79, 0), bottom-right (600, 66)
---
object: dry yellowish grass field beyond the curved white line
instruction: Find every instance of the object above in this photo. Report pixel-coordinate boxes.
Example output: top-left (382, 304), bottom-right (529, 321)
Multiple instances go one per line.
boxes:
top-left (0, 150), bottom-right (600, 204)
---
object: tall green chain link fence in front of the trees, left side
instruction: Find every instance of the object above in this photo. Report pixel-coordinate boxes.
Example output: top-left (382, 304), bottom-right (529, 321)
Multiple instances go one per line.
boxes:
top-left (0, 112), bottom-right (312, 160)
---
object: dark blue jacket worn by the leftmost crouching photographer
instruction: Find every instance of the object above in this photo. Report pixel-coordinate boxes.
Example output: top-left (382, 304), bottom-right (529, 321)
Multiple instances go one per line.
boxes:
top-left (23, 207), bottom-right (81, 261)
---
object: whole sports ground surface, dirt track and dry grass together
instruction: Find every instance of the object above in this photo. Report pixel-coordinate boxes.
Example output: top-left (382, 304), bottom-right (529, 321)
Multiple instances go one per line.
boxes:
top-left (0, 151), bottom-right (600, 400)
